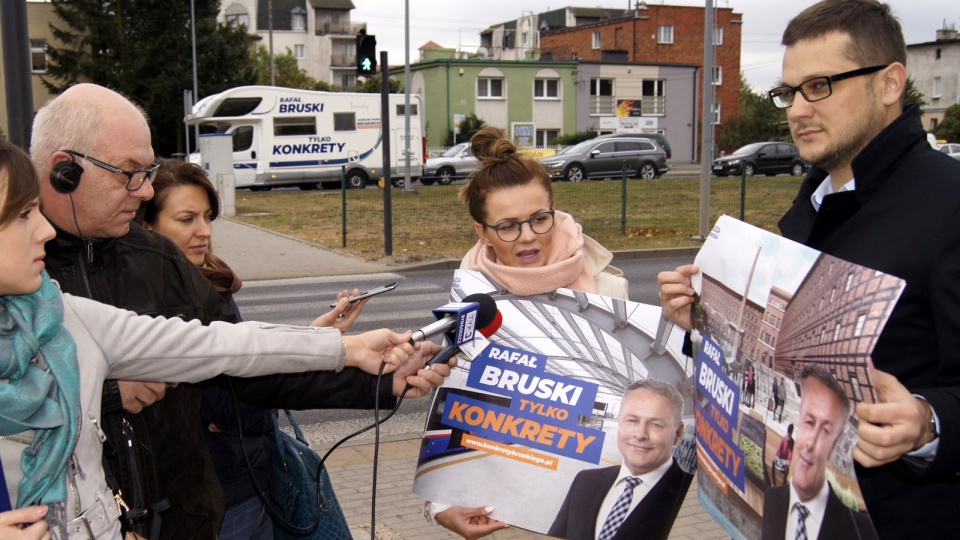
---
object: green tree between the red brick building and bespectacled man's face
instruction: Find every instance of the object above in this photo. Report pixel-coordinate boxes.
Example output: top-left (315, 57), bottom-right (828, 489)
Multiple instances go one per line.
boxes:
top-left (717, 73), bottom-right (786, 150)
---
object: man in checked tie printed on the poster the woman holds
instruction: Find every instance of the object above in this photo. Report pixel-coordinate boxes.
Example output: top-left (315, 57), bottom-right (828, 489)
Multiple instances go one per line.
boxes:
top-left (548, 379), bottom-right (693, 540)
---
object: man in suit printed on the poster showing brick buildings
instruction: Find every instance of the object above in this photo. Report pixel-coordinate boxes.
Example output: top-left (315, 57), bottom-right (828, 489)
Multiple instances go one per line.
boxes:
top-left (761, 364), bottom-right (877, 540)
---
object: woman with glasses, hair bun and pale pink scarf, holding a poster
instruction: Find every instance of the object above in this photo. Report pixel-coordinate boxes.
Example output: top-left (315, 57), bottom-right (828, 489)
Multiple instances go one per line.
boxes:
top-left (427, 127), bottom-right (627, 539)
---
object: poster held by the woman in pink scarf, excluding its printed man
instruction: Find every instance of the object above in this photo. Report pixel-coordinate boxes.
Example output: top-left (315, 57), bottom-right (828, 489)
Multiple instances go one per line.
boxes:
top-left (414, 270), bottom-right (696, 533)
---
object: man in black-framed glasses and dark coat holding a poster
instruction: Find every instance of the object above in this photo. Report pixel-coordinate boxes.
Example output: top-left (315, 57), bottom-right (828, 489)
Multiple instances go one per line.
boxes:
top-left (658, 0), bottom-right (960, 538)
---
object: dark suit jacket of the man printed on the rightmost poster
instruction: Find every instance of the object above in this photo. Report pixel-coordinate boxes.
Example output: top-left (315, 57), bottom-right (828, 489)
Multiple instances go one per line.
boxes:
top-left (760, 482), bottom-right (877, 540)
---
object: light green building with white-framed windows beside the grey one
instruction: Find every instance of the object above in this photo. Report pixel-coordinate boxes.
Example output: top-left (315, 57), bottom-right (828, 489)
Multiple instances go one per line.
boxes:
top-left (390, 42), bottom-right (577, 147)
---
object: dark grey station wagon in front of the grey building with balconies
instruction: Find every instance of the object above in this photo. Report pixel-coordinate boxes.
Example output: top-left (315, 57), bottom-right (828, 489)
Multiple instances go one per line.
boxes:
top-left (539, 137), bottom-right (670, 182)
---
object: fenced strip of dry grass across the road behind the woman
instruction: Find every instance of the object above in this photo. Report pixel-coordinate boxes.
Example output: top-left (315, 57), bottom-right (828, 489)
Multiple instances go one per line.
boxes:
top-left (236, 176), bottom-right (800, 261)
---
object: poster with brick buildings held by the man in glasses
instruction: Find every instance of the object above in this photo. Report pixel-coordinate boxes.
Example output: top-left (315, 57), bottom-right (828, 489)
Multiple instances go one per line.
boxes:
top-left (693, 216), bottom-right (904, 539)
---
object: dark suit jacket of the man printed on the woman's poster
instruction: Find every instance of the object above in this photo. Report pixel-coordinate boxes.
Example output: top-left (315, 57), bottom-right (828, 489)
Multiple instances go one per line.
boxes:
top-left (548, 461), bottom-right (693, 540)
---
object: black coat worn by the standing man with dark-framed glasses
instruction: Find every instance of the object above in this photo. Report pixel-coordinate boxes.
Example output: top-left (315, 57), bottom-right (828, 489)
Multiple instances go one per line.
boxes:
top-left (780, 107), bottom-right (960, 538)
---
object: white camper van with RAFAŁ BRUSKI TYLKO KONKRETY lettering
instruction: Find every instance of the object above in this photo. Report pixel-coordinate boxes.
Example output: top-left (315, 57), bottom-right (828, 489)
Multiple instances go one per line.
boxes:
top-left (185, 86), bottom-right (424, 191)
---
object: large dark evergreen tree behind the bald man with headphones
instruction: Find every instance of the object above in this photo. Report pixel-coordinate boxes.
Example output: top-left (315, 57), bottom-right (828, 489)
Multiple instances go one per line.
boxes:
top-left (43, 0), bottom-right (255, 155)
